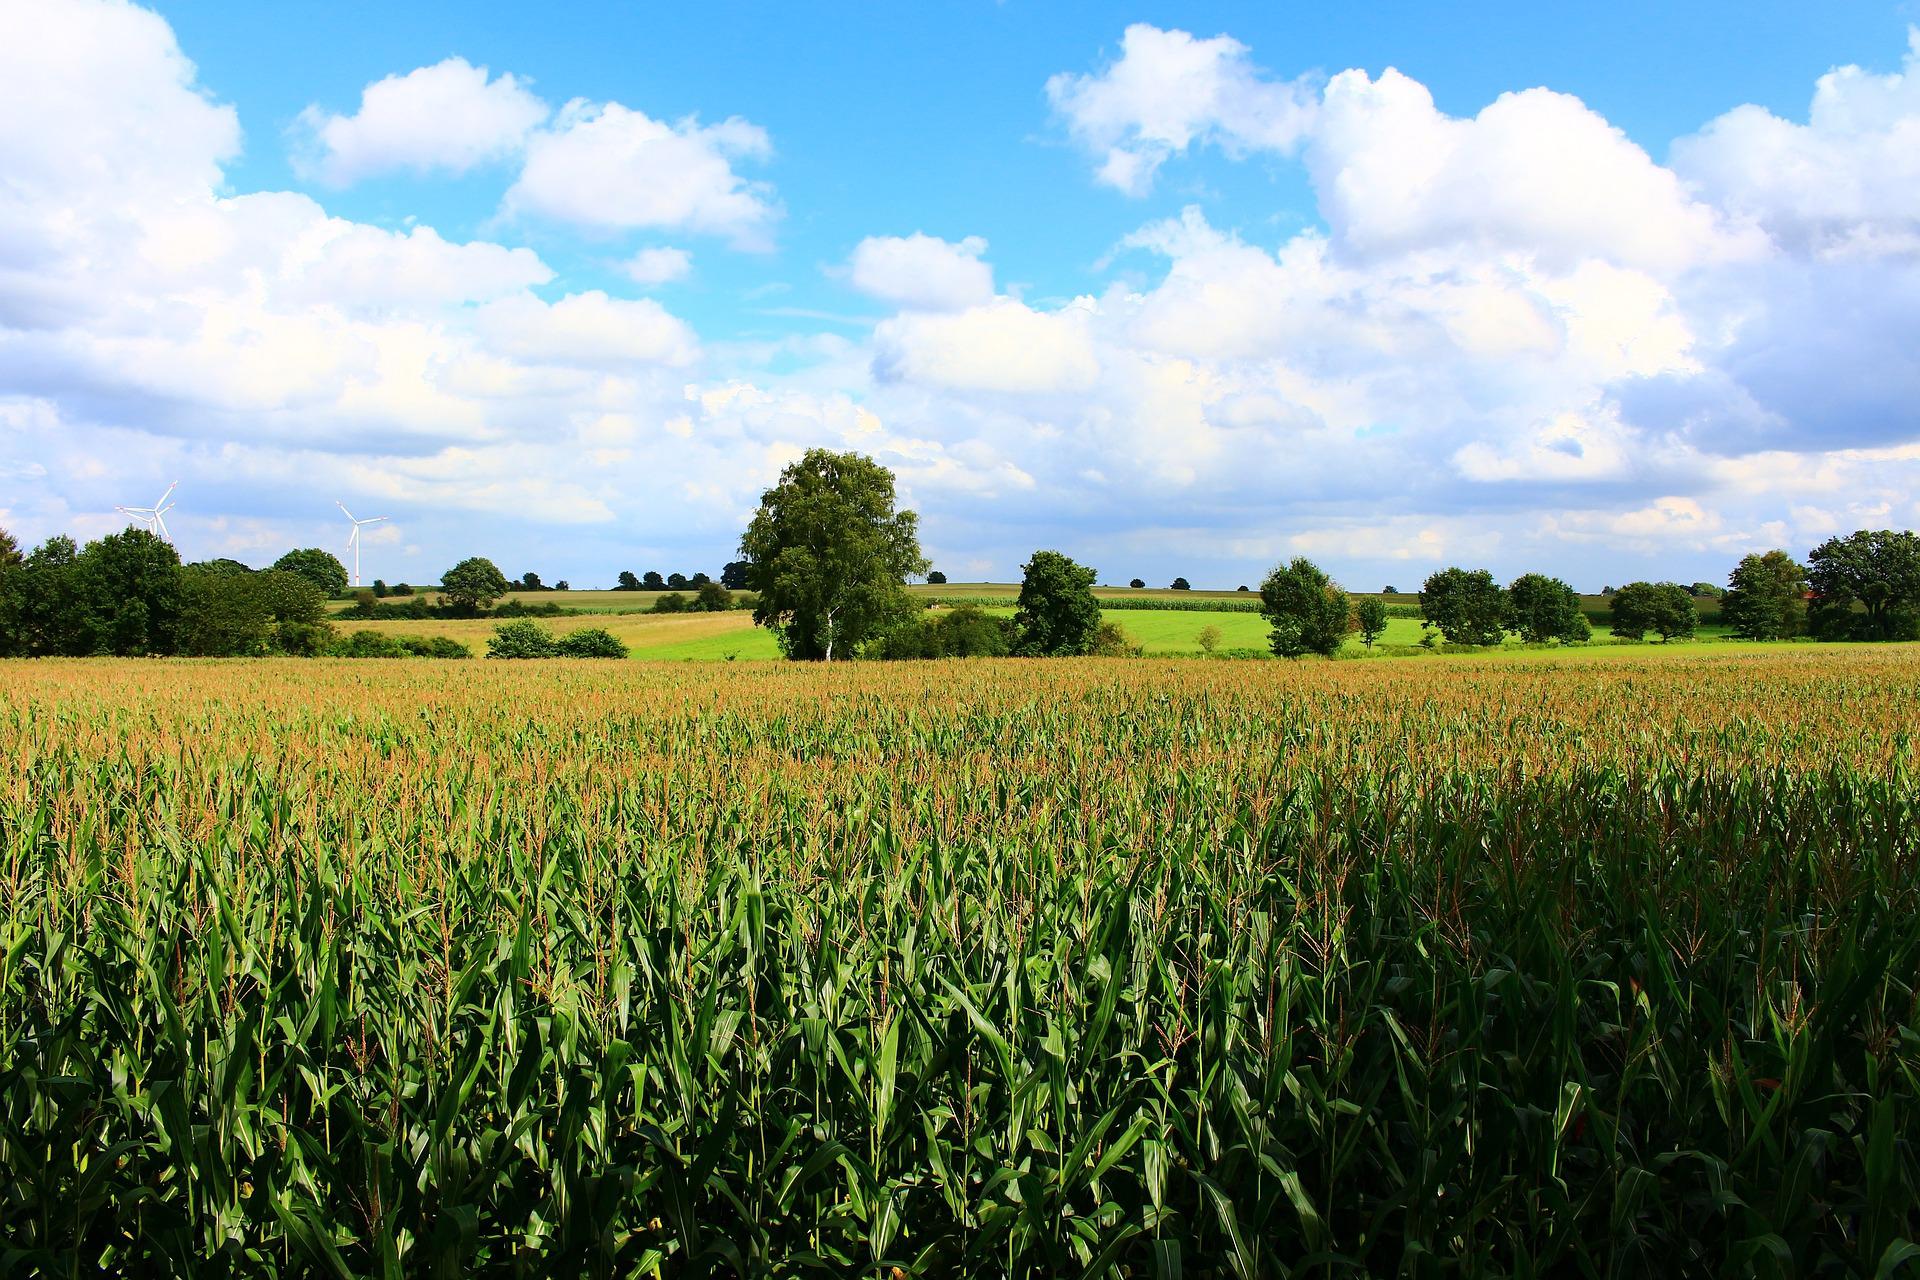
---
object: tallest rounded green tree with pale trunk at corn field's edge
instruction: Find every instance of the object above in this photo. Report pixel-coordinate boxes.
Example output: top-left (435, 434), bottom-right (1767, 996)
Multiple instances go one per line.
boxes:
top-left (739, 449), bottom-right (927, 662)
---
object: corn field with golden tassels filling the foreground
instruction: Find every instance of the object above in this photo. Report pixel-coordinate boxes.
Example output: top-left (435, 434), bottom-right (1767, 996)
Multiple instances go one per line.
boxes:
top-left (0, 649), bottom-right (1920, 1280)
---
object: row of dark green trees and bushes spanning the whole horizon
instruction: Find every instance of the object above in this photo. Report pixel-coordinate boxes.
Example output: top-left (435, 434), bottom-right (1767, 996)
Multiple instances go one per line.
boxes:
top-left (0, 458), bottom-right (1920, 662)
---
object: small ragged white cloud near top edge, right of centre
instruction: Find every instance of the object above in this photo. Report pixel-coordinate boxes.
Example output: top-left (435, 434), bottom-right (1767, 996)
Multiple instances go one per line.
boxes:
top-left (1046, 23), bottom-right (1313, 196)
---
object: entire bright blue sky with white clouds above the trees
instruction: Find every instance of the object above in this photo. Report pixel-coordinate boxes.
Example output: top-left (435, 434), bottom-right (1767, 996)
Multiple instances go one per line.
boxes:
top-left (0, 0), bottom-right (1920, 589)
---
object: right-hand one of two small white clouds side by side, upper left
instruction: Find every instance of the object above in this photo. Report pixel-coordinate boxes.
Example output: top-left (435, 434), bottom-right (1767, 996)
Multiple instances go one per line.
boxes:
top-left (507, 100), bottom-right (778, 248)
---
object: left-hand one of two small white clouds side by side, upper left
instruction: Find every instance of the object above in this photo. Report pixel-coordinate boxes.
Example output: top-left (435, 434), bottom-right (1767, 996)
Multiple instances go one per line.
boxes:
top-left (296, 58), bottom-right (549, 186)
